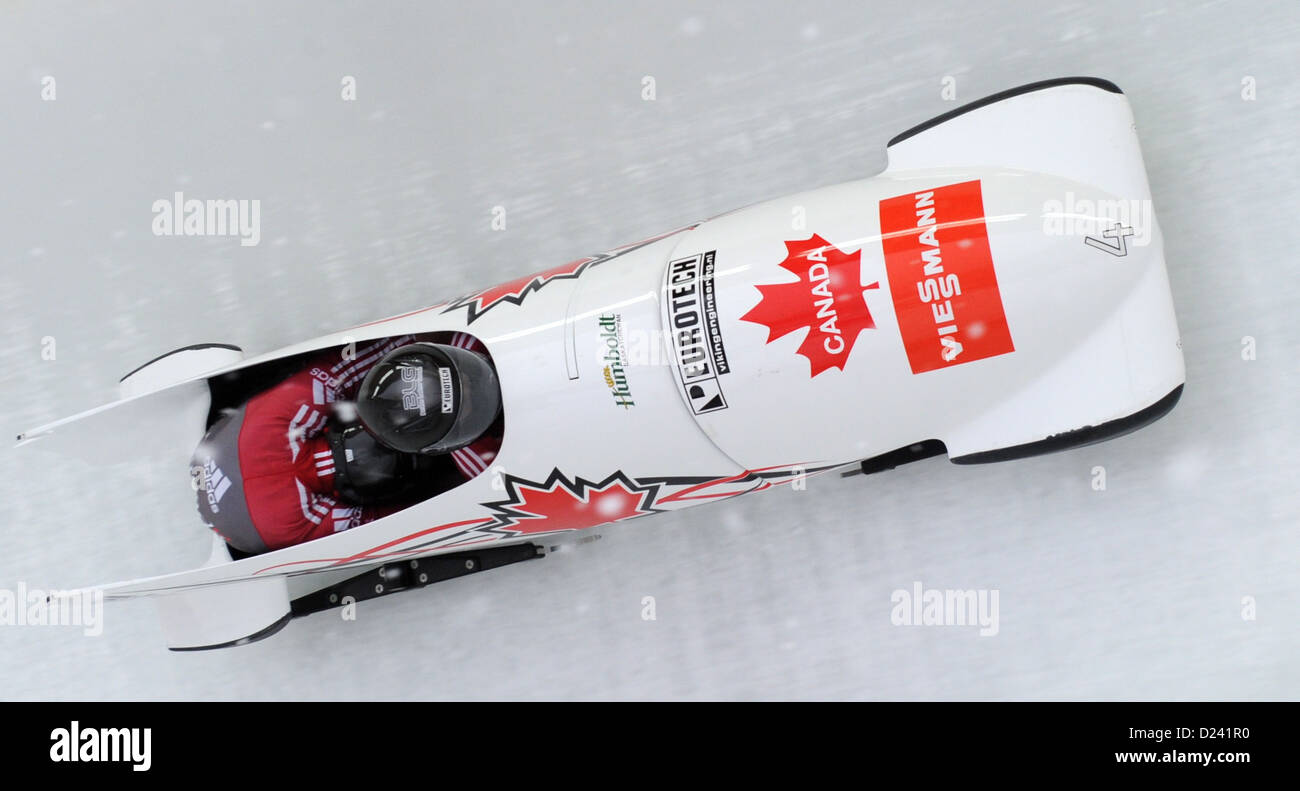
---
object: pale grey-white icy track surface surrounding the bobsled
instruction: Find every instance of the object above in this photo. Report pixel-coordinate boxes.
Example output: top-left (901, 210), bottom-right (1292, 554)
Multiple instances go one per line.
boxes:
top-left (0, 1), bottom-right (1300, 699)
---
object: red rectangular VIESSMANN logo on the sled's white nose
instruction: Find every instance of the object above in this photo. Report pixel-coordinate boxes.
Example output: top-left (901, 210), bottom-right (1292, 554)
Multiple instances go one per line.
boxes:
top-left (880, 181), bottom-right (1015, 373)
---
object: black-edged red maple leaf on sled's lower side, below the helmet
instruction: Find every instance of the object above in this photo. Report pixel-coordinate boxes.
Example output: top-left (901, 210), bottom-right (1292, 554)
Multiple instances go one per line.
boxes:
top-left (488, 470), bottom-right (659, 535)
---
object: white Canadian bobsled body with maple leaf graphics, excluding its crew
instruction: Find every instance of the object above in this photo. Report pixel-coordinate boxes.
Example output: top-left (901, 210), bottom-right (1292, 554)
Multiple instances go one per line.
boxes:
top-left (20, 78), bottom-right (1184, 650)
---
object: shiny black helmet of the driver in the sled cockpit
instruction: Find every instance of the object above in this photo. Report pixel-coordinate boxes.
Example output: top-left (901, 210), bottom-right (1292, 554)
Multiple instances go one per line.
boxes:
top-left (356, 343), bottom-right (501, 453)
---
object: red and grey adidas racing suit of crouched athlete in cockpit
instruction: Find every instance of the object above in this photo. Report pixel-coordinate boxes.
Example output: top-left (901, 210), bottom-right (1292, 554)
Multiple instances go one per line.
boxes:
top-left (195, 333), bottom-right (501, 553)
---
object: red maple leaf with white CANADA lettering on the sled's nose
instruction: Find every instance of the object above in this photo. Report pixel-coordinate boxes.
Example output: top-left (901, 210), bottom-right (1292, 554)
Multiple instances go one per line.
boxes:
top-left (741, 234), bottom-right (880, 376)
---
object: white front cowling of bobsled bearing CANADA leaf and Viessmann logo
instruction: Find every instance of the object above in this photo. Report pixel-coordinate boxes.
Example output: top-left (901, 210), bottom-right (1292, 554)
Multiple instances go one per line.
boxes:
top-left (666, 81), bottom-right (1184, 467)
